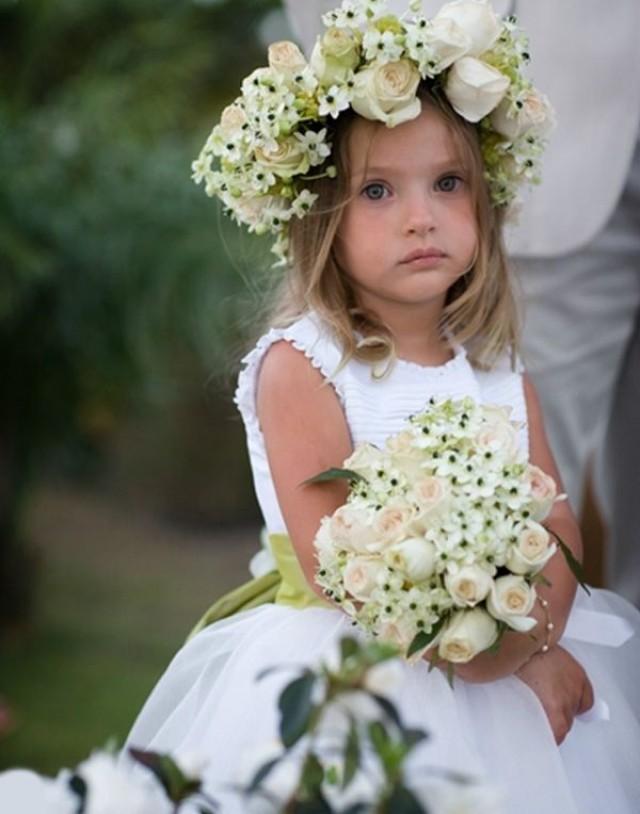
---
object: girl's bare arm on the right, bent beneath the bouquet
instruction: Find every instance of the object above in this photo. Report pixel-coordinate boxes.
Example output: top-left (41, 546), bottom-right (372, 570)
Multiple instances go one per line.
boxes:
top-left (456, 376), bottom-right (582, 682)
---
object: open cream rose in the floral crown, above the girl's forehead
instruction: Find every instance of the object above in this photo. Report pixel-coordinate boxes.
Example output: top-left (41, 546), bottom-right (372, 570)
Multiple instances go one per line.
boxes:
top-left (351, 59), bottom-right (422, 127)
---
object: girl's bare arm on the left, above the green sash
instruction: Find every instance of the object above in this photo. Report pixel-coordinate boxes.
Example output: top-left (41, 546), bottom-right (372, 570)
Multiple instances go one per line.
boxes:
top-left (257, 341), bottom-right (353, 598)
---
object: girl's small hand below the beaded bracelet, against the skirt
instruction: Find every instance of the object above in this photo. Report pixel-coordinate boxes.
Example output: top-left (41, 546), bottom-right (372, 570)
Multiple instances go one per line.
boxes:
top-left (515, 645), bottom-right (593, 744)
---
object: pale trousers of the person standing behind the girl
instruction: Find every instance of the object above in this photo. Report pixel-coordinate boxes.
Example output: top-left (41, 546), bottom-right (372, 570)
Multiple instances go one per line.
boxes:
top-left (516, 135), bottom-right (640, 607)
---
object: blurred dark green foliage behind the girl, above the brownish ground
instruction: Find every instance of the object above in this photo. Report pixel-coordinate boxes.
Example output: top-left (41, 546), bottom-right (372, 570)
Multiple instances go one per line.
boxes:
top-left (0, 0), bottom-right (278, 621)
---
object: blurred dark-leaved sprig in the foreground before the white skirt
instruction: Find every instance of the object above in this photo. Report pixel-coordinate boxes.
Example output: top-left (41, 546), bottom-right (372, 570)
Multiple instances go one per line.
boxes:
top-left (252, 637), bottom-right (428, 814)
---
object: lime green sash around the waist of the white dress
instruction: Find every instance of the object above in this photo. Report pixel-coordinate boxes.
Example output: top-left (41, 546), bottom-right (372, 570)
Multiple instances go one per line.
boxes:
top-left (187, 534), bottom-right (332, 641)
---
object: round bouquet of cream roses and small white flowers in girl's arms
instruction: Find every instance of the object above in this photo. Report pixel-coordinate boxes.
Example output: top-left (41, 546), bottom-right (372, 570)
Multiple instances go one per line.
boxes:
top-left (313, 398), bottom-right (564, 663)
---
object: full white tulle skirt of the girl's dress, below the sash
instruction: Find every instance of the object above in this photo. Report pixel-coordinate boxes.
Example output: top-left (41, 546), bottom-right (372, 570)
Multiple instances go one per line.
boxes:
top-left (128, 590), bottom-right (640, 814)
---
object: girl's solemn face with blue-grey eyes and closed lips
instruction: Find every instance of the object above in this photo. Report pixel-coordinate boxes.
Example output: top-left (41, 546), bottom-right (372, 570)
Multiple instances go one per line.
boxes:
top-left (335, 104), bottom-right (477, 319)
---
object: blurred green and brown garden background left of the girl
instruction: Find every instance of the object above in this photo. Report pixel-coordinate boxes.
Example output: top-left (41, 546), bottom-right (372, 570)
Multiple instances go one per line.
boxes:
top-left (0, 0), bottom-right (290, 773)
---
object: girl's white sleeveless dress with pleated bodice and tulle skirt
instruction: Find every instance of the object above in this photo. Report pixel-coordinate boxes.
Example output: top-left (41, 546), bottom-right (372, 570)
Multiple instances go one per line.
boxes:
top-left (6, 316), bottom-right (640, 814)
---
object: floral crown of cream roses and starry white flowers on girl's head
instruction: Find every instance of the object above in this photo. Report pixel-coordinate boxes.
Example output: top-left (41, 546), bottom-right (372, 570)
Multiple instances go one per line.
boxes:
top-left (192, 0), bottom-right (554, 265)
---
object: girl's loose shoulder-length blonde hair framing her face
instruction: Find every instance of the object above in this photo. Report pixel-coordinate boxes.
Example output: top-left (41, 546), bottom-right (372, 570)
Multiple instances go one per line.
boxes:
top-left (258, 87), bottom-right (518, 369)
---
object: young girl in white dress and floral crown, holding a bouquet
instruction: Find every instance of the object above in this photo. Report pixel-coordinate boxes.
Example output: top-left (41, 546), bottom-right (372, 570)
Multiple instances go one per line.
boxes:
top-left (114, 2), bottom-right (640, 814)
